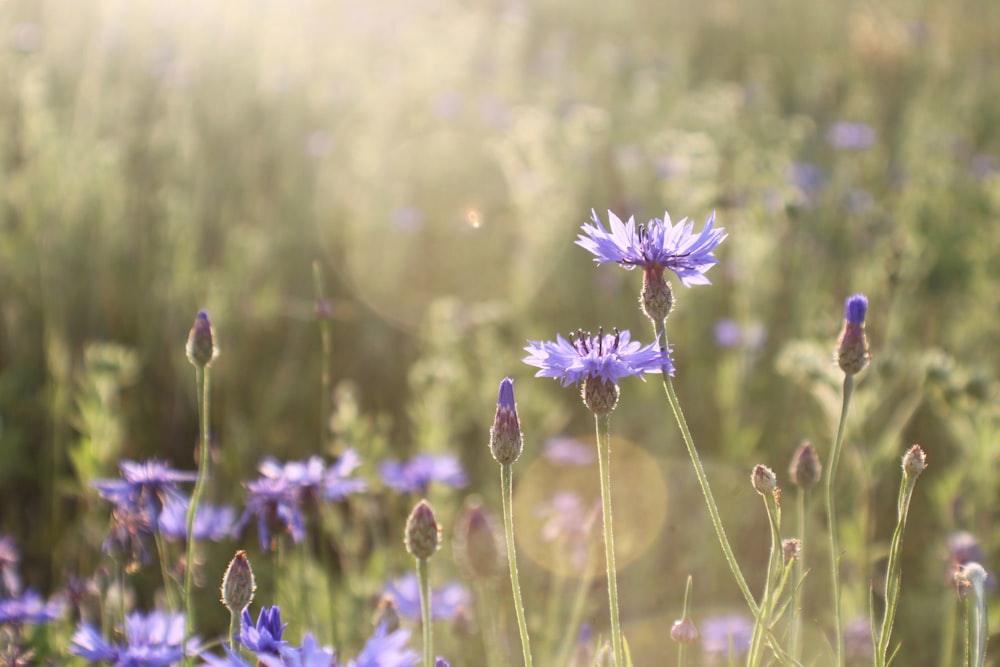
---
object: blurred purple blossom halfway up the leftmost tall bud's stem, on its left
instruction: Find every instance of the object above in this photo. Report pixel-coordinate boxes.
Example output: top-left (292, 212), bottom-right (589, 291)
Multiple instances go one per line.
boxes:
top-left (91, 460), bottom-right (198, 524)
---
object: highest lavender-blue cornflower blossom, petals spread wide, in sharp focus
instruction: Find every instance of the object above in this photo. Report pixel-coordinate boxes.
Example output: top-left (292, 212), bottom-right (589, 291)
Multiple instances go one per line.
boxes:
top-left (576, 211), bottom-right (726, 287)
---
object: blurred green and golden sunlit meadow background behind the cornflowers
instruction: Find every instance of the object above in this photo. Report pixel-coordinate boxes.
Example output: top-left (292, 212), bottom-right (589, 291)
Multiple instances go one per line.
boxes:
top-left (0, 0), bottom-right (1000, 666)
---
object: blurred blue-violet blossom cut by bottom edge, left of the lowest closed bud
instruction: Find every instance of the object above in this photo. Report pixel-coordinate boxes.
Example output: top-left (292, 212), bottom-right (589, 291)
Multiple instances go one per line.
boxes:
top-left (70, 611), bottom-right (198, 667)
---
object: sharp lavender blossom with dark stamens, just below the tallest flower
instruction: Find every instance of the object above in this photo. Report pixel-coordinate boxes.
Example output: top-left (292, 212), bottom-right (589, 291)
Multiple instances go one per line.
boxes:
top-left (522, 329), bottom-right (674, 387)
